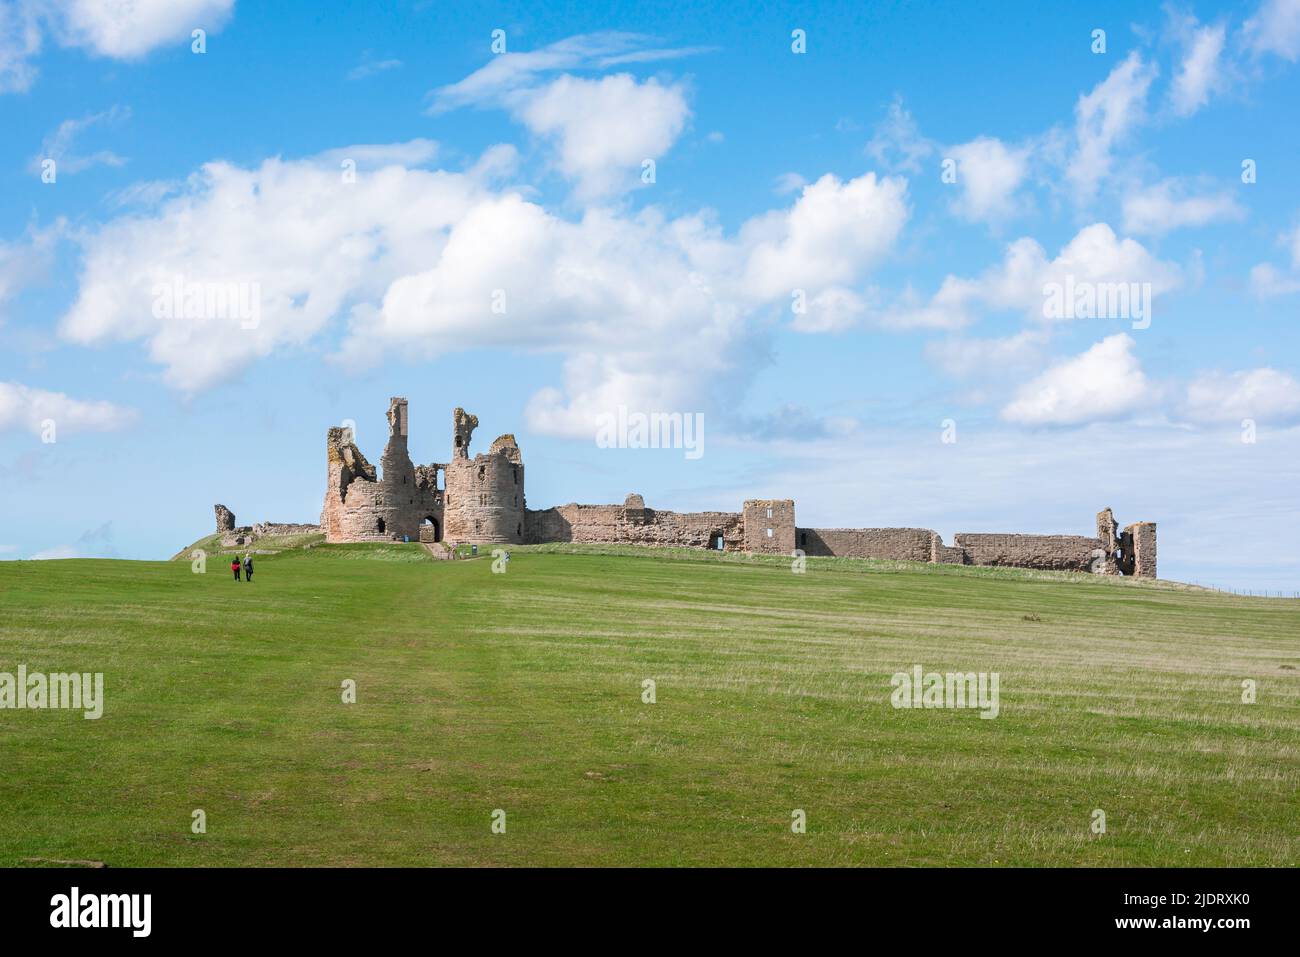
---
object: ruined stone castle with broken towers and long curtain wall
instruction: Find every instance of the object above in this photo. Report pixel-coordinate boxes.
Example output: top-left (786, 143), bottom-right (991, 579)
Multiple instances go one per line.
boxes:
top-left (216, 398), bottom-right (1156, 579)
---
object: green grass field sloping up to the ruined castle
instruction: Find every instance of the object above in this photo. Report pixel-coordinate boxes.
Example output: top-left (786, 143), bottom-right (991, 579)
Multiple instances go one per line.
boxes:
top-left (0, 542), bottom-right (1300, 866)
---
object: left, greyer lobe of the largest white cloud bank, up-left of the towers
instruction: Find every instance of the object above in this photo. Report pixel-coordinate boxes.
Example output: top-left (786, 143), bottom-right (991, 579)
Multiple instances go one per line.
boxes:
top-left (60, 144), bottom-right (491, 391)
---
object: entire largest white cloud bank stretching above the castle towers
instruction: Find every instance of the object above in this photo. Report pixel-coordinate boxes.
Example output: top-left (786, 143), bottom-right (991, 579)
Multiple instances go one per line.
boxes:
top-left (60, 144), bottom-right (907, 434)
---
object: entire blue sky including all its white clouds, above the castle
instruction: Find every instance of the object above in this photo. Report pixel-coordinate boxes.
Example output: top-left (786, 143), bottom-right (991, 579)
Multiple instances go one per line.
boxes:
top-left (0, 0), bottom-right (1300, 590)
